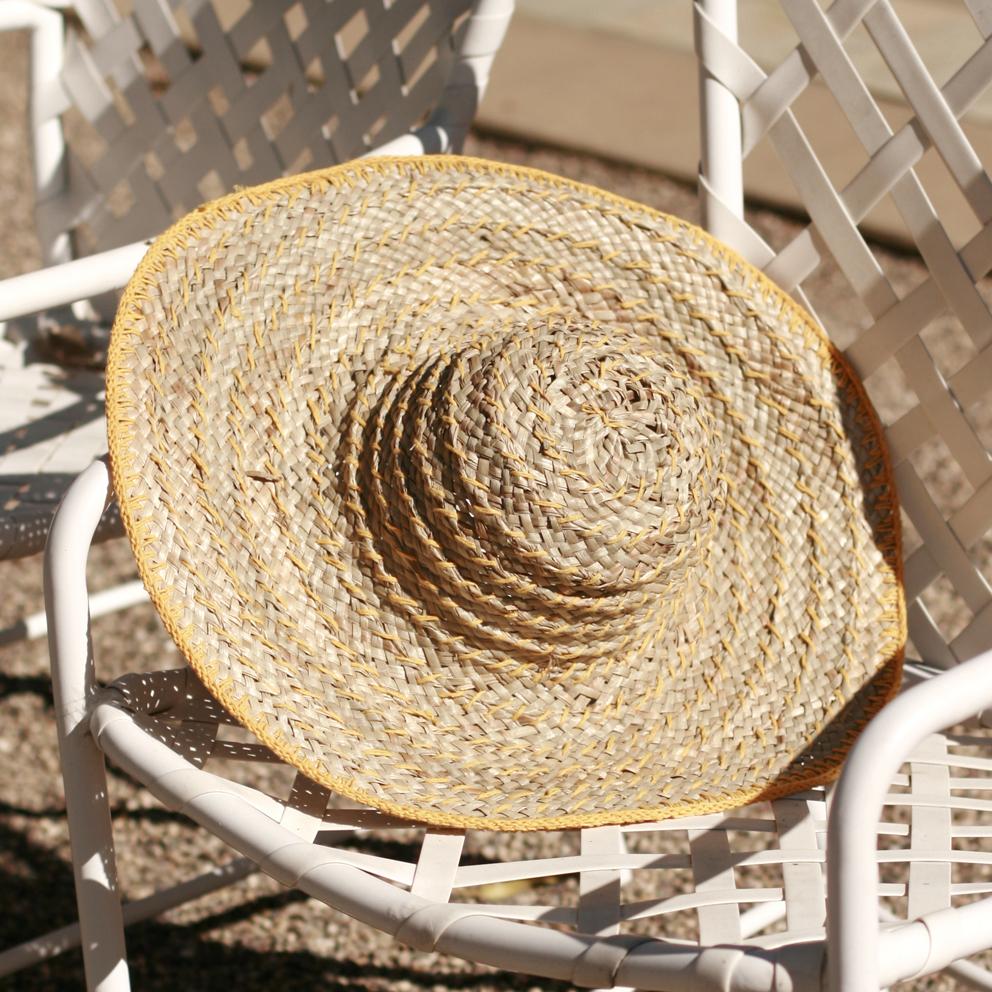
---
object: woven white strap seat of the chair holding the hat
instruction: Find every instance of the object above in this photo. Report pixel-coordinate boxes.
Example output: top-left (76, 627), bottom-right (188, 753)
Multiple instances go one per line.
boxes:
top-left (91, 669), bottom-right (992, 990)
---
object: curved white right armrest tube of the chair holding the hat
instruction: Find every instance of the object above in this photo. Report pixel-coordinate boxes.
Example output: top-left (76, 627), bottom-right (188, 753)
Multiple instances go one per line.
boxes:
top-left (827, 651), bottom-right (992, 992)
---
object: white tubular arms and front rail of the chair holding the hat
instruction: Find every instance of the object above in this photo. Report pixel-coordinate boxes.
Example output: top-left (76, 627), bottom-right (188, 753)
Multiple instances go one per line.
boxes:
top-left (38, 461), bottom-right (992, 992)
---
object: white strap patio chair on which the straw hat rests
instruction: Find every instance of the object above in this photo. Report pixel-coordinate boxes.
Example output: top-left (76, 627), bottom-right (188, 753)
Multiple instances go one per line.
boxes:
top-left (35, 0), bottom-right (992, 992)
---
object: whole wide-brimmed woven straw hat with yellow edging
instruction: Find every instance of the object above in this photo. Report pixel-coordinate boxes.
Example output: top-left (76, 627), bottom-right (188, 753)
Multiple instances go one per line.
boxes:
top-left (108, 158), bottom-right (905, 830)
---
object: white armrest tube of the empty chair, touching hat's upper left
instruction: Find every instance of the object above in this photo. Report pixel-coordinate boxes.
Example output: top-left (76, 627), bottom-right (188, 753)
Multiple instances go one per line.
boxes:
top-left (0, 239), bottom-right (150, 320)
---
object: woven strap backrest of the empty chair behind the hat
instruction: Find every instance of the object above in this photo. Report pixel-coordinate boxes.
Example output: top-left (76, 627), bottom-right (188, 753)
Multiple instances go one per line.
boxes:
top-left (27, 0), bottom-right (512, 270)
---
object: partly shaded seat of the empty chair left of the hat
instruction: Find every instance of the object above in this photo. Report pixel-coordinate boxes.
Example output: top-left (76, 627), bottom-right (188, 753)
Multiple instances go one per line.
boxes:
top-left (0, 326), bottom-right (123, 560)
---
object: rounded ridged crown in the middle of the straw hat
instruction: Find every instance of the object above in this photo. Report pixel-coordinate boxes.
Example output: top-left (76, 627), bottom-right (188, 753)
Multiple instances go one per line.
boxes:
top-left (351, 321), bottom-right (726, 661)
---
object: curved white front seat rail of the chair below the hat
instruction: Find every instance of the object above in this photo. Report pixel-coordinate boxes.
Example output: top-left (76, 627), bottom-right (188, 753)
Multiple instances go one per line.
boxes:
top-left (94, 705), bottom-right (776, 992)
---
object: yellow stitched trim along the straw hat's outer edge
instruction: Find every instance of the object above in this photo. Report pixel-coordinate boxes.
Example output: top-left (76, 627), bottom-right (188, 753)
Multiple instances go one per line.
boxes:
top-left (106, 155), bottom-right (907, 831)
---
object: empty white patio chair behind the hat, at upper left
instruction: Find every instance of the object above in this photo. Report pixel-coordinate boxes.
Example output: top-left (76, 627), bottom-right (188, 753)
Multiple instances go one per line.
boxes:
top-left (0, 0), bottom-right (511, 643)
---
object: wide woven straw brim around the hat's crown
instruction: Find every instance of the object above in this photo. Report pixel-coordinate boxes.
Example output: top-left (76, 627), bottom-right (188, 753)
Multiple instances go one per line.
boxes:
top-left (107, 157), bottom-right (906, 830)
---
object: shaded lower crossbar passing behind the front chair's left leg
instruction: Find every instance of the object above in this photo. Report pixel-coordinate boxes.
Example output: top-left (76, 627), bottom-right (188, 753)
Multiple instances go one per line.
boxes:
top-left (0, 858), bottom-right (258, 978)
